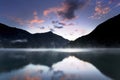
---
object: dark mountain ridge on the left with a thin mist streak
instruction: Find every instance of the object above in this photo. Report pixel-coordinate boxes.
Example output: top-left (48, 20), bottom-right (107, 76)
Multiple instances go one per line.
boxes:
top-left (0, 24), bottom-right (68, 48)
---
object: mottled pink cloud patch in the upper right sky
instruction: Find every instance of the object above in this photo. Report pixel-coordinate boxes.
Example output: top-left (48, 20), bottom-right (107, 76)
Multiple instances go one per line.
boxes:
top-left (90, 1), bottom-right (111, 19)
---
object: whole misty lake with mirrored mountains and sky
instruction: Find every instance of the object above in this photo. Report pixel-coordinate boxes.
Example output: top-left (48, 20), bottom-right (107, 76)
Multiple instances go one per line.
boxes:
top-left (0, 48), bottom-right (120, 80)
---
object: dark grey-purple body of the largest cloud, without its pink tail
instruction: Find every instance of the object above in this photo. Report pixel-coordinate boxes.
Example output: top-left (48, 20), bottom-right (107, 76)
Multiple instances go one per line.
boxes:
top-left (57, 0), bottom-right (88, 20)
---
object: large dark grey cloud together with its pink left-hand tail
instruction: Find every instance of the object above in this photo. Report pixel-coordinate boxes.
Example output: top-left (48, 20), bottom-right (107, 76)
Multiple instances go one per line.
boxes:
top-left (43, 0), bottom-right (90, 20)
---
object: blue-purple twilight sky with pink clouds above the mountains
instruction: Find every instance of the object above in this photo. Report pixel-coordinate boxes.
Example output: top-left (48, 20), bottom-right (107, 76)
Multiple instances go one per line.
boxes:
top-left (0, 0), bottom-right (120, 40)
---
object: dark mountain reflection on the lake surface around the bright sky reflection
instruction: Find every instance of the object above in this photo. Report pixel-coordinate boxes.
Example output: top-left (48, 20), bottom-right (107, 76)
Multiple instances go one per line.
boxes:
top-left (0, 49), bottom-right (120, 80)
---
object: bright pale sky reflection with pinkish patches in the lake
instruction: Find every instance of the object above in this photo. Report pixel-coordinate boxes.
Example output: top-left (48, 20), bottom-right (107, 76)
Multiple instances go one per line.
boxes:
top-left (0, 56), bottom-right (111, 80)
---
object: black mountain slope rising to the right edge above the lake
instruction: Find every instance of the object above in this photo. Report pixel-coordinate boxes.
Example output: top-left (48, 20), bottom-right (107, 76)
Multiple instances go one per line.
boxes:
top-left (69, 14), bottom-right (120, 47)
